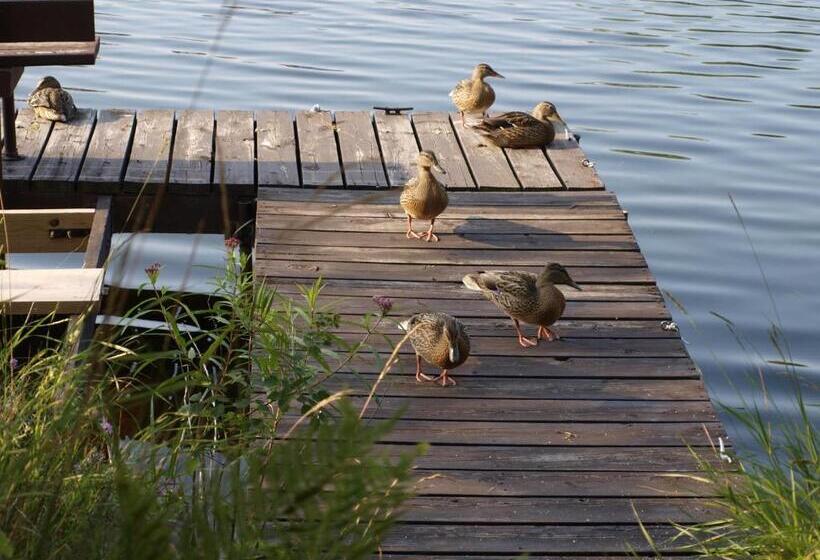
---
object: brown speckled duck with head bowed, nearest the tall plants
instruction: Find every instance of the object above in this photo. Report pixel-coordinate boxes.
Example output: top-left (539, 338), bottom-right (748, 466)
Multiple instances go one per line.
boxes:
top-left (399, 313), bottom-right (470, 387)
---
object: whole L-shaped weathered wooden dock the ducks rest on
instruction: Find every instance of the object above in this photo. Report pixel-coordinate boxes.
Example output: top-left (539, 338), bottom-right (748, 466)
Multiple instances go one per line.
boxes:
top-left (3, 109), bottom-right (723, 560)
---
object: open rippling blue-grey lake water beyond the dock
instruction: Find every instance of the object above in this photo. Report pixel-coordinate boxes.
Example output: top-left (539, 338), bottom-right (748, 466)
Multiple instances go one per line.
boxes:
top-left (14, 0), bottom-right (820, 446)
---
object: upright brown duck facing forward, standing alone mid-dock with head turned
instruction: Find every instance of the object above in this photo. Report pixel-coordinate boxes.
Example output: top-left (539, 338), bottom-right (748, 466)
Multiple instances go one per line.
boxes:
top-left (399, 150), bottom-right (450, 241)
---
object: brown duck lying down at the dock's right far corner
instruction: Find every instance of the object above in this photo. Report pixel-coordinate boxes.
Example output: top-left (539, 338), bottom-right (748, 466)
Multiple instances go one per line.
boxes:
top-left (475, 101), bottom-right (560, 148)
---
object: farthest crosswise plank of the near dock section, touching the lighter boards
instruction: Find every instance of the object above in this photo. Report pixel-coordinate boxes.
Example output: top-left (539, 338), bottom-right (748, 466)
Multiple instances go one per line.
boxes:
top-left (259, 187), bottom-right (620, 207)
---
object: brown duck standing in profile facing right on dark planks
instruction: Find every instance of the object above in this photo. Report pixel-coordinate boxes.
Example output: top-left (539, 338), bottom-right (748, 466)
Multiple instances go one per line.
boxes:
top-left (462, 263), bottom-right (581, 348)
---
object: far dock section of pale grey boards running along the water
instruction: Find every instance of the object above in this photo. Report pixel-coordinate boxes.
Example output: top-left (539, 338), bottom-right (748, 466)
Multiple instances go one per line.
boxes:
top-left (4, 109), bottom-right (603, 195)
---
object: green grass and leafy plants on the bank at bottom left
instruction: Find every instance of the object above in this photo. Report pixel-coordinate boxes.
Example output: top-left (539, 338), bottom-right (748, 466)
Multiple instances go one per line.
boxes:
top-left (0, 249), bottom-right (421, 560)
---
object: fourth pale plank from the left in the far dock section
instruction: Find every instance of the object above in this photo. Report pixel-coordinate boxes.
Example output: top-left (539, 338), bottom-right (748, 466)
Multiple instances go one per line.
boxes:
top-left (123, 109), bottom-right (174, 194)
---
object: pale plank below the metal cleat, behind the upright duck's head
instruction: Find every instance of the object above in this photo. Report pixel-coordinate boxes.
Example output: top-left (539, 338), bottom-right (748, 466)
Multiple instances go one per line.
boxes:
top-left (375, 111), bottom-right (420, 187)
